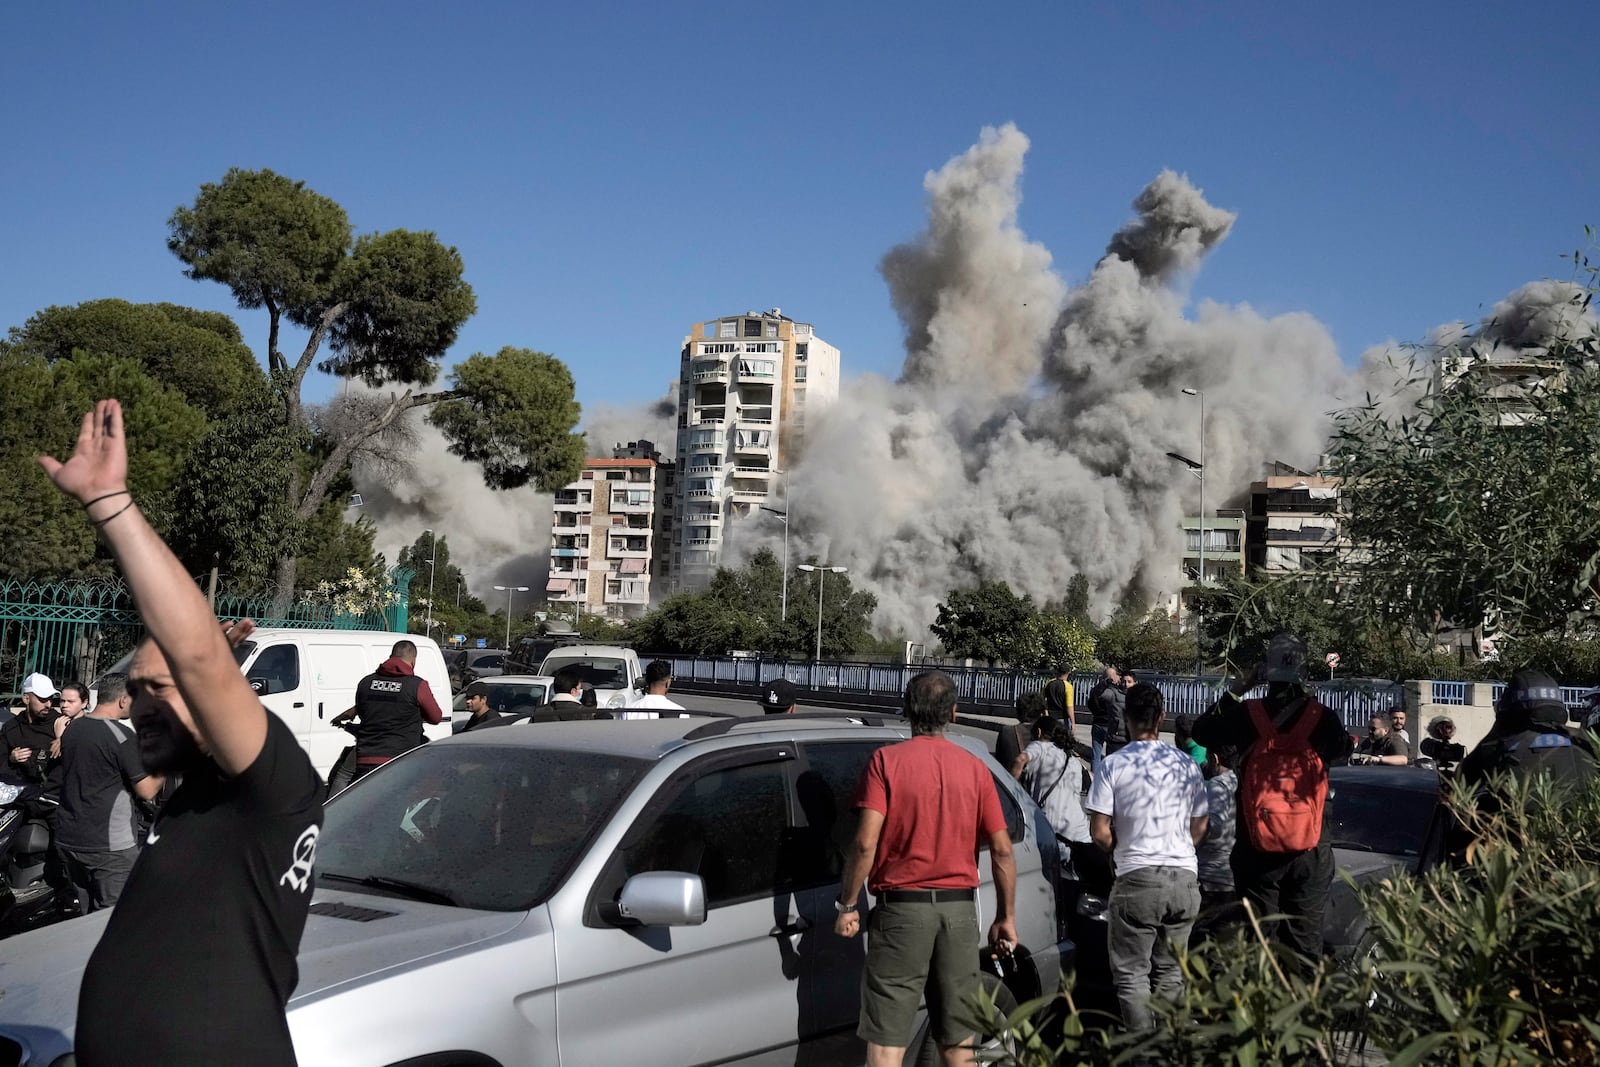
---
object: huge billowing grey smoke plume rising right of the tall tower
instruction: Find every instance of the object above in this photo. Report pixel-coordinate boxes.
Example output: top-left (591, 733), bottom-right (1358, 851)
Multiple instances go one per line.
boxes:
top-left (736, 125), bottom-right (1355, 638)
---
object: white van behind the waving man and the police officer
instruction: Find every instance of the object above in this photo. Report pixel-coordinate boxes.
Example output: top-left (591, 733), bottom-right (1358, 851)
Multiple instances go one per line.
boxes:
top-left (97, 629), bottom-right (451, 777)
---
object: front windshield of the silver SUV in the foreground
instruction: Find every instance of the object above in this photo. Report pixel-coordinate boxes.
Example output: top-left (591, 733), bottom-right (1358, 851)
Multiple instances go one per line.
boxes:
top-left (317, 744), bottom-right (650, 912)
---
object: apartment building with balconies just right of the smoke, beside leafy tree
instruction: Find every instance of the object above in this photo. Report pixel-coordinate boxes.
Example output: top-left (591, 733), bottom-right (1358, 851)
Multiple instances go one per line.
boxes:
top-left (1241, 462), bottom-right (1349, 576)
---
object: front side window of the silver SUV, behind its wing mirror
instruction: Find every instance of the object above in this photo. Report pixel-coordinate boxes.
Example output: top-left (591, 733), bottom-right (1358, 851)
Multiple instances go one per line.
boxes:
top-left (602, 761), bottom-right (789, 907)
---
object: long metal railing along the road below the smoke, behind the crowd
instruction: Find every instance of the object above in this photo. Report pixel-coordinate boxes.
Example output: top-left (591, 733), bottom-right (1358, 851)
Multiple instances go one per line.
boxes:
top-left (640, 653), bottom-right (1405, 729)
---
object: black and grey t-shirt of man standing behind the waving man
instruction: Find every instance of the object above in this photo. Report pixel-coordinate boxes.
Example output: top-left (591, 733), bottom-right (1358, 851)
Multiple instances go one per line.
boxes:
top-left (56, 715), bottom-right (146, 853)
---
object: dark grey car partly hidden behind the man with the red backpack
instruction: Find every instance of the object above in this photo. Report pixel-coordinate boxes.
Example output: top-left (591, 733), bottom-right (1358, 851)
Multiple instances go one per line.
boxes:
top-left (1059, 765), bottom-right (1446, 998)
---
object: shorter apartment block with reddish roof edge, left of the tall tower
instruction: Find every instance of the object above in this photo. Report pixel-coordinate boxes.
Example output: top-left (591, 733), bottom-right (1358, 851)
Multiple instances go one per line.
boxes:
top-left (546, 442), bottom-right (662, 619)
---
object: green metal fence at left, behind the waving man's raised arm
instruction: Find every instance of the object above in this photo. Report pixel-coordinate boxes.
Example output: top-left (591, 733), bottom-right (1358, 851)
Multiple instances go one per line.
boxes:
top-left (0, 568), bottom-right (411, 696)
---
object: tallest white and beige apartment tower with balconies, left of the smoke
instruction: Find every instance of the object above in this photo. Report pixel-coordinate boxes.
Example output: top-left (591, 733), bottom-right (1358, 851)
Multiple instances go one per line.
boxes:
top-left (670, 307), bottom-right (838, 587)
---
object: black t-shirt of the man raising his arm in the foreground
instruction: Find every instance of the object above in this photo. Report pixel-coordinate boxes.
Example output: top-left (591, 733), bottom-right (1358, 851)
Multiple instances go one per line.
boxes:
top-left (77, 713), bottom-right (325, 1067)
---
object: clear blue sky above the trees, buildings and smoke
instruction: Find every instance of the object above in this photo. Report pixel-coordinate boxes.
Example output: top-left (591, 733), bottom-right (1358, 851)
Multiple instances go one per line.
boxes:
top-left (0, 0), bottom-right (1600, 415)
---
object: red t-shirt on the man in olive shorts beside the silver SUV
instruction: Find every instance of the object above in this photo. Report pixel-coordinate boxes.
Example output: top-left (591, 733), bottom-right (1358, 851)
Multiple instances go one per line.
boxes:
top-left (856, 737), bottom-right (1005, 893)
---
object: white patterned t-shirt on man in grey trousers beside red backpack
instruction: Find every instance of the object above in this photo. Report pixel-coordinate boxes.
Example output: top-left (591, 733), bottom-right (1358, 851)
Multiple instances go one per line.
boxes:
top-left (1083, 741), bottom-right (1206, 873)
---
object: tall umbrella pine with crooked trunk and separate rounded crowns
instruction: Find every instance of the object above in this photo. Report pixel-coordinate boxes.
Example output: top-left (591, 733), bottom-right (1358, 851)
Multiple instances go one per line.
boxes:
top-left (168, 168), bottom-right (584, 597)
